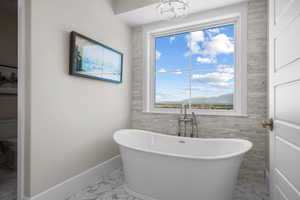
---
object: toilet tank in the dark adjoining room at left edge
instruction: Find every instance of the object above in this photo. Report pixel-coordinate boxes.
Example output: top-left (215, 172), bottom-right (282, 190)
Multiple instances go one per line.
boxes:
top-left (0, 119), bottom-right (17, 140)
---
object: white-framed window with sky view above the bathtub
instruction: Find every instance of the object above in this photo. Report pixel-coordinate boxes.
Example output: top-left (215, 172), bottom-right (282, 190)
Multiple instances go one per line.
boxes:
top-left (147, 17), bottom-right (246, 115)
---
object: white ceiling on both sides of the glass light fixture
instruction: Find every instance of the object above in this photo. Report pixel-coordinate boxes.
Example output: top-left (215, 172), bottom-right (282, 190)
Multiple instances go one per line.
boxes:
top-left (113, 0), bottom-right (247, 26)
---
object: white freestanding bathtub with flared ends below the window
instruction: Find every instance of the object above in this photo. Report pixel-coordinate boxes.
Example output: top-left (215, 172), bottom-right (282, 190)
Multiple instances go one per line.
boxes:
top-left (114, 129), bottom-right (252, 200)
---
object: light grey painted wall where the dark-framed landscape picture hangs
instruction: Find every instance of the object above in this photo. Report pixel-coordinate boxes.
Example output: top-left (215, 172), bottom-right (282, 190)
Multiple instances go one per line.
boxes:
top-left (25, 0), bottom-right (131, 197)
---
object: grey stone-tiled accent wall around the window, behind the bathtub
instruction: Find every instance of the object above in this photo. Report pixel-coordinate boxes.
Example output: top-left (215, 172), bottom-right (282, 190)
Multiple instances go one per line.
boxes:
top-left (131, 0), bottom-right (267, 182)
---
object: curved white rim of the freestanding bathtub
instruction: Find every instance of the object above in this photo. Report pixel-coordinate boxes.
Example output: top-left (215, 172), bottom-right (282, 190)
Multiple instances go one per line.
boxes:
top-left (113, 129), bottom-right (253, 160)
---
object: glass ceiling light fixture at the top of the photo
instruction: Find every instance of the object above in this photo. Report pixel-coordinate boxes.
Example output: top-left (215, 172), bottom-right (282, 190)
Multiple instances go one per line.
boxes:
top-left (157, 0), bottom-right (190, 19)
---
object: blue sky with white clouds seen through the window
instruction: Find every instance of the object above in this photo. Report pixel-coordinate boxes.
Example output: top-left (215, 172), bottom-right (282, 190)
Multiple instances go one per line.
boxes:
top-left (155, 25), bottom-right (235, 102)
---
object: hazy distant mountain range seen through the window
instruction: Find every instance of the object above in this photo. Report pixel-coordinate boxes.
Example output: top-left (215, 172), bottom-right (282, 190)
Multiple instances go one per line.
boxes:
top-left (157, 93), bottom-right (233, 105)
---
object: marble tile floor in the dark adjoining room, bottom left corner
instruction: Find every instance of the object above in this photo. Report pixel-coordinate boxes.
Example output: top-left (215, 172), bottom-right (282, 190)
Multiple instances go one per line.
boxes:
top-left (0, 168), bottom-right (17, 200)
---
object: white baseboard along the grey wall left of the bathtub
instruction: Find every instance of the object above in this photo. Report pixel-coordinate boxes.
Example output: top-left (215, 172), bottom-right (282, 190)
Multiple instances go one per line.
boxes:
top-left (24, 155), bottom-right (122, 200)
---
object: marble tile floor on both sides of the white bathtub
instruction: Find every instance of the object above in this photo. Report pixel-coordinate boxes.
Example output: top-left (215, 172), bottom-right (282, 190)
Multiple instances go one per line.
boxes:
top-left (66, 169), bottom-right (269, 200)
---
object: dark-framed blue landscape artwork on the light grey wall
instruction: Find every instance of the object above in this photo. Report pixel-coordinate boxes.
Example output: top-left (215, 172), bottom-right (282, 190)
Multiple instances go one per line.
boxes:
top-left (69, 31), bottom-right (123, 83)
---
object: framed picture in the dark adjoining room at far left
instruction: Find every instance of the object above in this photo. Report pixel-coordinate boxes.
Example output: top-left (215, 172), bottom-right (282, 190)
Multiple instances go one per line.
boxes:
top-left (0, 65), bottom-right (18, 95)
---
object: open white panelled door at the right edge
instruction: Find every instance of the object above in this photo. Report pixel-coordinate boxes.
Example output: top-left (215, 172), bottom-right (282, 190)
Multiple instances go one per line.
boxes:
top-left (269, 0), bottom-right (300, 200)
